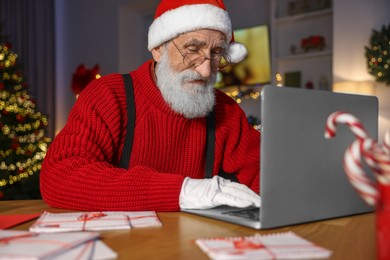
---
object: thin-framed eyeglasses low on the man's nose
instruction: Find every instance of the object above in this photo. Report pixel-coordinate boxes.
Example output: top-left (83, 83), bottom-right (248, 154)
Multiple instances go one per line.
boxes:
top-left (172, 41), bottom-right (230, 71)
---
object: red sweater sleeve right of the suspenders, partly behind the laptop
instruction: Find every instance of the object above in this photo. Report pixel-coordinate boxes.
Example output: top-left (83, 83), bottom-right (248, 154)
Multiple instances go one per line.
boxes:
top-left (214, 92), bottom-right (260, 192)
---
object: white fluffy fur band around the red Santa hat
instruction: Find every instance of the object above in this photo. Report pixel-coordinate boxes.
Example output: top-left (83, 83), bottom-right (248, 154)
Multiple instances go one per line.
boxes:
top-left (148, 4), bottom-right (232, 51)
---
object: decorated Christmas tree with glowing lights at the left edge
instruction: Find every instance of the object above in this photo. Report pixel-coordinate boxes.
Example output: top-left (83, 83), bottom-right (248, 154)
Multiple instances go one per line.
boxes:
top-left (0, 33), bottom-right (51, 200)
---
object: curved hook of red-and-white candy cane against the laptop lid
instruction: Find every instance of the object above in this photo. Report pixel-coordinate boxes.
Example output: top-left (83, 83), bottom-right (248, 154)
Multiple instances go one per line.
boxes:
top-left (325, 111), bottom-right (368, 139)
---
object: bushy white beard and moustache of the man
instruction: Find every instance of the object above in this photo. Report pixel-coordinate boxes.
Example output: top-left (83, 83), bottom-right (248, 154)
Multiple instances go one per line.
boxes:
top-left (156, 48), bottom-right (216, 119)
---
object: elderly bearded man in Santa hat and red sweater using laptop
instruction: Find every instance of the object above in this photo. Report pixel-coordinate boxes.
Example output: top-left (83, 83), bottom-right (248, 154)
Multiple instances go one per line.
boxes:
top-left (41, 0), bottom-right (260, 211)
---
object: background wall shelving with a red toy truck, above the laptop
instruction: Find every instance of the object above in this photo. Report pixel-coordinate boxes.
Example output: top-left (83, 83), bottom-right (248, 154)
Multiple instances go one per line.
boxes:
top-left (271, 0), bottom-right (335, 85)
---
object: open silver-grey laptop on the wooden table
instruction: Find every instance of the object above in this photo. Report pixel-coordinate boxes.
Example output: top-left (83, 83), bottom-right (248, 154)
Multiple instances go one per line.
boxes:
top-left (185, 85), bottom-right (378, 229)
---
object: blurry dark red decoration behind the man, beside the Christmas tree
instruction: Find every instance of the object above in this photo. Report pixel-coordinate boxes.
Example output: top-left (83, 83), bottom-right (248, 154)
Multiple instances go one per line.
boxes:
top-left (71, 64), bottom-right (100, 95)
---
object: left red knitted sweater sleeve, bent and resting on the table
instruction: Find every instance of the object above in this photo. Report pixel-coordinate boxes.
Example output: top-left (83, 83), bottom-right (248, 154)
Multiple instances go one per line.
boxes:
top-left (40, 75), bottom-right (184, 211)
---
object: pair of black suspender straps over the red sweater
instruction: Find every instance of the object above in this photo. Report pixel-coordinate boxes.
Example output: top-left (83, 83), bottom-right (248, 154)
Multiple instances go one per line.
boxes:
top-left (119, 74), bottom-right (219, 178)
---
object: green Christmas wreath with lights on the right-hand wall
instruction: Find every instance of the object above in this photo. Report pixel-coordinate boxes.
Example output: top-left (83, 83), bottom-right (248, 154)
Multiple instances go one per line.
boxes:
top-left (365, 24), bottom-right (390, 86)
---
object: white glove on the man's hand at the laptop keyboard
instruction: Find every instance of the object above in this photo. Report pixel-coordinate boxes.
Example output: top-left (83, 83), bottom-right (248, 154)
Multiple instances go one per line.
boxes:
top-left (179, 176), bottom-right (260, 209)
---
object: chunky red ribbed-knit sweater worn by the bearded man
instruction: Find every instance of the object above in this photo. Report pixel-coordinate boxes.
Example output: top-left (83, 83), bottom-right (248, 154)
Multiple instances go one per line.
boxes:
top-left (40, 62), bottom-right (260, 211)
